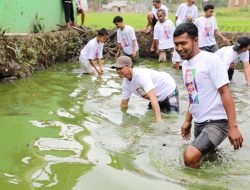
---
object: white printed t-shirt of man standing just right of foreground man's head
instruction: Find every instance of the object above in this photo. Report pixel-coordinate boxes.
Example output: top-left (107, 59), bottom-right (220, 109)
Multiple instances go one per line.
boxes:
top-left (195, 16), bottom-right (218, 47)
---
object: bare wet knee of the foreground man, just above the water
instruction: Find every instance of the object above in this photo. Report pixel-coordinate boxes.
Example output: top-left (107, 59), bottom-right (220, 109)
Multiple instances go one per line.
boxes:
top-left (183, 145), bottom-right (202, 168)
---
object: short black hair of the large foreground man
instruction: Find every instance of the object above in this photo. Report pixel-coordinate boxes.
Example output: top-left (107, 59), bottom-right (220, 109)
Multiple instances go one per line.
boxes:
top-left (174, 23), bottom-right (198, 39)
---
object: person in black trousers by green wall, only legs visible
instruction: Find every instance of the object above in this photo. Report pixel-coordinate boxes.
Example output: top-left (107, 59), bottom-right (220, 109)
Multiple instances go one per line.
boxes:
top-left (63, 0), bottom-right (75, 29)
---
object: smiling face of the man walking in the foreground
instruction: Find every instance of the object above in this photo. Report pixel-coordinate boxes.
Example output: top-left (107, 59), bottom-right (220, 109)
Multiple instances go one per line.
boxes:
top-left (174, 33), bottom-right (198, 60)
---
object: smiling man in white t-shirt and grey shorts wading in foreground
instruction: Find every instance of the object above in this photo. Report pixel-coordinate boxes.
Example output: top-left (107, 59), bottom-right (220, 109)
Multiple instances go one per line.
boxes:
top-left (174, 23), bottom-right (243, 168)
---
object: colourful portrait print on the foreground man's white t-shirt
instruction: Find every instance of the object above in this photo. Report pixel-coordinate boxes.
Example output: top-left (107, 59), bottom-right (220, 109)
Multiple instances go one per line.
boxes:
top-left (185, 69), bottom-right (199, 104)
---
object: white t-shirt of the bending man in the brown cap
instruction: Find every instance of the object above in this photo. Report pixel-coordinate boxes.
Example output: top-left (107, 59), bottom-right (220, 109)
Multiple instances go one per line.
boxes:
top-left (122, 68), bottom-right (176, 102)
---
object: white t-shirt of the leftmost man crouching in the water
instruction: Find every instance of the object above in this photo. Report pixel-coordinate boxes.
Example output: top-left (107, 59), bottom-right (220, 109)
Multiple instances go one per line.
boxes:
top-left (80, 38), bottom-right (104, 60)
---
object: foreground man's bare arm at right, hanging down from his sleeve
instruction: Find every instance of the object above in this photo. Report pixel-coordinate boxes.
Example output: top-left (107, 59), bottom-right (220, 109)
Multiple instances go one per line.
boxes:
top-left (218, 84), bottom-right (243, 149)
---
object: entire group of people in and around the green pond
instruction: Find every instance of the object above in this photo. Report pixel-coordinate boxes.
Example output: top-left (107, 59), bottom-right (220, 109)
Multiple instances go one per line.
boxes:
top-left (70, 0), bottom-right (250, 168)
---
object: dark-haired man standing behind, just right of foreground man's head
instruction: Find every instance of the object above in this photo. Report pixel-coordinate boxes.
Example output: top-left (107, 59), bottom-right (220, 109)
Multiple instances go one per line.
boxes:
top-left (194, 4), bottom-right (230, 53)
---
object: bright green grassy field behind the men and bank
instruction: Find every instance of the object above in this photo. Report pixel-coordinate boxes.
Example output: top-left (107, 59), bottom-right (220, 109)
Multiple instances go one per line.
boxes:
top-left (77, 8), bottom-right (250, 32)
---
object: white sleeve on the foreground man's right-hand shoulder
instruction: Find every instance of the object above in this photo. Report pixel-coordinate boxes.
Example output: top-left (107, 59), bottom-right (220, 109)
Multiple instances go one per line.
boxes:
top-left (208, 54), bottom-right (229, 89)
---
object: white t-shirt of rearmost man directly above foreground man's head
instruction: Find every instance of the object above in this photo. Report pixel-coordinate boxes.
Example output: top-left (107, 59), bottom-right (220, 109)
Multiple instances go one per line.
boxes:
top-left (175, 3), bottom-right (198, 26)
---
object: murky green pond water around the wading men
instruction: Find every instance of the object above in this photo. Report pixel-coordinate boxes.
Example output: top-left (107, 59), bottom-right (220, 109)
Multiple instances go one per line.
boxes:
top-left (0, 59), bottom-right (250, 190)
